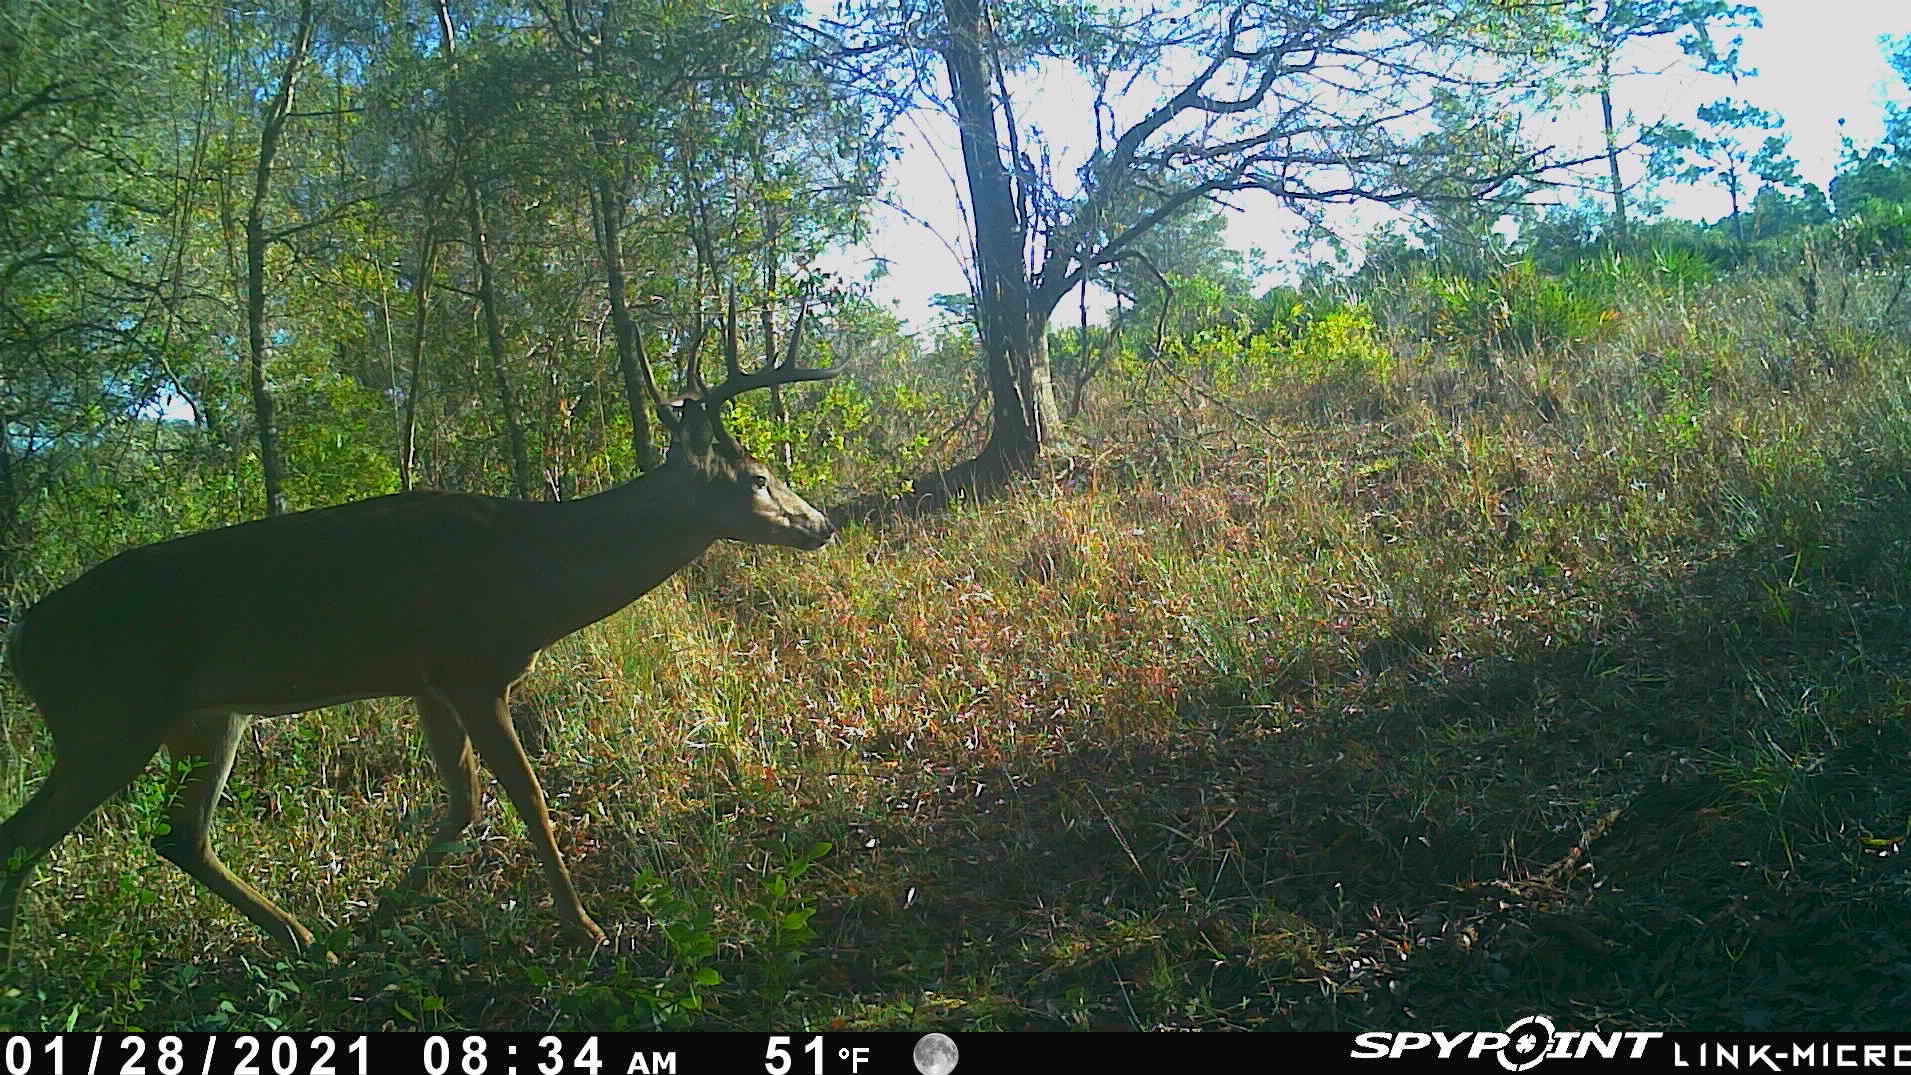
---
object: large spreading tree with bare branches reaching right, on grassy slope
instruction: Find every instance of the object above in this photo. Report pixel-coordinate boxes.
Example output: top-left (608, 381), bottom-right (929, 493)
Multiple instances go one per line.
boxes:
top-left (831, 0), bottom-right (1582, 485)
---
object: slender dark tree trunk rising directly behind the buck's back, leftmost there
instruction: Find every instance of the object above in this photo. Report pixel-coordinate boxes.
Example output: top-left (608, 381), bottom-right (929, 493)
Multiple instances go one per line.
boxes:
top-left (245, 0), bottom-right (311, 516)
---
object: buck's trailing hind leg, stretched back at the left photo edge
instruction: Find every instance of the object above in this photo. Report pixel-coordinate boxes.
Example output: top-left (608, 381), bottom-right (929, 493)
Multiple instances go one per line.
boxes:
top-left (0, 735), bottom-right (159, 970)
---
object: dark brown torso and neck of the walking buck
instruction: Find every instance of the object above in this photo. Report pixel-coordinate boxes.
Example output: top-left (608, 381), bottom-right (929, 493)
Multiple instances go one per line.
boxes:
top-left (10, 474), bottom-right (717, 716)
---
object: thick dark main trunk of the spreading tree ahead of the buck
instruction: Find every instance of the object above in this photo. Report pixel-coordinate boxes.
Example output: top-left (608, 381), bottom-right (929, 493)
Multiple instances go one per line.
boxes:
top-left (942, 0), bottom-right (1061, 477)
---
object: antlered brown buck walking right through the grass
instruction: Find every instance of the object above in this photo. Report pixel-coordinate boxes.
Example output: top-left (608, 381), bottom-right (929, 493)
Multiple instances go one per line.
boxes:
top-left (0, 292), bottom-right (839, 968)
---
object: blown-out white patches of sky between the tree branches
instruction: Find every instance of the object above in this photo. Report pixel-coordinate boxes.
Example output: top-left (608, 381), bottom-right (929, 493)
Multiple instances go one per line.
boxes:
top-left (837, 0), bottom-right (1911, 328)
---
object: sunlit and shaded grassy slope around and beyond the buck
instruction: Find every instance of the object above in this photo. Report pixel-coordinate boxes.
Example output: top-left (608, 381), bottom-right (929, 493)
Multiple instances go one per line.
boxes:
top-left (0, 263), bottom-right (1911, 1029)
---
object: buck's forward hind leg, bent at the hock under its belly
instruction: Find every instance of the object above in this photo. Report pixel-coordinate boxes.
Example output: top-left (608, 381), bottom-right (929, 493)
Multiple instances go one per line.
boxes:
top-left (153, 714), bottom-right (311, 951)
